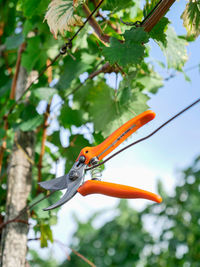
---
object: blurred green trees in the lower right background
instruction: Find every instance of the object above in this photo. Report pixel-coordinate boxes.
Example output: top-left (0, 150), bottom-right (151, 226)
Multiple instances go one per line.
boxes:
top-left (58, 157), bottom-right (200, 267)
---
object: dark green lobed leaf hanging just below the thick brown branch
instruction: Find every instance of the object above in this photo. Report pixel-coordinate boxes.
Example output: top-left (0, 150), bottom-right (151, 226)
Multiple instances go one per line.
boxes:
top-left (102, 27), bottom-right (148, 66)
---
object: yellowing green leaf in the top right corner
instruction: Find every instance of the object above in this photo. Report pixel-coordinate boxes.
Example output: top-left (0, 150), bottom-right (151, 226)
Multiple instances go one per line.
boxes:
top-left (181, 1), bottom-right (200, 38)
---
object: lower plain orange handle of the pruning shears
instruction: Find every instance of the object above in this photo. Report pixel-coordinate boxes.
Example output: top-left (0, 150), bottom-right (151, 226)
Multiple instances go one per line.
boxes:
top-left (77, 180), bottom-right (162, 203)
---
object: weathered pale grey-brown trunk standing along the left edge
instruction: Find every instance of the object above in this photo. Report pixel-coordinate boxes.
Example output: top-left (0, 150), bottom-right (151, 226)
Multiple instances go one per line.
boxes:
top-left (1, 67), bottom-right (34, 267)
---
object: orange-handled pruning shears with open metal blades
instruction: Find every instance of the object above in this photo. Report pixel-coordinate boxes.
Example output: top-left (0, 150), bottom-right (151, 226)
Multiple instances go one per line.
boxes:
top-left (40, 110), bottom-right (162, 210)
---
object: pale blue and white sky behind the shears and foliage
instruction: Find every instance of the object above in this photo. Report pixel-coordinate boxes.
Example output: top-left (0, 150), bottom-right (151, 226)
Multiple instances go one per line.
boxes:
top-left (30, 1), bottom-right (200, 261)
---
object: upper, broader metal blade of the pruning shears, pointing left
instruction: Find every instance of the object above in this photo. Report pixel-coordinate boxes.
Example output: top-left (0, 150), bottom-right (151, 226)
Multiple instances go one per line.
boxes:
top-left (39, 174), bottom-right (68, 191)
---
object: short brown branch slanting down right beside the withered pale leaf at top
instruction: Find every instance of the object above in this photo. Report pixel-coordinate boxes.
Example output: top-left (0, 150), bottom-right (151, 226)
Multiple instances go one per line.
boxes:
top-left (83, 4), bottom-right (110, 44)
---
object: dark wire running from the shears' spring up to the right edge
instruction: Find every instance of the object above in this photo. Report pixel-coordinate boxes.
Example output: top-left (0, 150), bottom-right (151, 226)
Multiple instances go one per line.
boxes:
top-left (86, 98), bottom-right (200, 171)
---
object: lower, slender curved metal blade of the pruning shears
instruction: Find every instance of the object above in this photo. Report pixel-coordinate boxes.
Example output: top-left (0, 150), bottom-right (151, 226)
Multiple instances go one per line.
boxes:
top-left (43, 177), bottom-right (82, 211)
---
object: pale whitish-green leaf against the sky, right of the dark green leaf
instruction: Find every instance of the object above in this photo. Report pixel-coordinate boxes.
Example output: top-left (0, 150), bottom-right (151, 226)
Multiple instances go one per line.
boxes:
top-left (160, 27), bottom-right (188, 70)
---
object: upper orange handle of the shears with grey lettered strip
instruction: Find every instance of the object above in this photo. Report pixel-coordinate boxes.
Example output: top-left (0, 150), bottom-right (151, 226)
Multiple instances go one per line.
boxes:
top-left (77, 110), bottom-right (156, 164)
